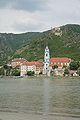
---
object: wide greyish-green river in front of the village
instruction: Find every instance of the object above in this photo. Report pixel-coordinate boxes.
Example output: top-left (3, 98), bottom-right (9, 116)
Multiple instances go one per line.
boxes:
top-left (0, 77), bottom-right (80, 120)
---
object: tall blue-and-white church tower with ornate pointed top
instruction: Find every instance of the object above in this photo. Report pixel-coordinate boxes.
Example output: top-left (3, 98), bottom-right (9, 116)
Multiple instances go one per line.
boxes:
top-left (43, 46), bottom-right (50, 75)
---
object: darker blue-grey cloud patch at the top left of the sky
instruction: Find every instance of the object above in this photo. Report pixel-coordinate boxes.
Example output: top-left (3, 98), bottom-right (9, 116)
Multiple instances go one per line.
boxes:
top-left (0, 0), bottom-right (47, 12)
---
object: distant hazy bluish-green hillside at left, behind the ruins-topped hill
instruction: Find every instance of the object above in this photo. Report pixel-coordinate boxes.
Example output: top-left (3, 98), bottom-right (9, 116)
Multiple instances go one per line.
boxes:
top-left (0, 32), bottom-right (39, 64)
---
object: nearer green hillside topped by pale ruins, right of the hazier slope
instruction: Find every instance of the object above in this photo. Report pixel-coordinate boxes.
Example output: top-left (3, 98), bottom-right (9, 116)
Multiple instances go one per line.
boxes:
top-left (13, 24), bottom-right (80, 60)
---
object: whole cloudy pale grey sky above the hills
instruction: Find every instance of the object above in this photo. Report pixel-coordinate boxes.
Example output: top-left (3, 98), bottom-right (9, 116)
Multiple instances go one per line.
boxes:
top-left (0, 0), bottom-right (80, 33)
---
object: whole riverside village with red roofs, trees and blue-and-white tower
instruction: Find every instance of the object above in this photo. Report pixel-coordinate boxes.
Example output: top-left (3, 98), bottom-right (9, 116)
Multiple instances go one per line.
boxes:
top-left (0, 46), bottom-right (80, 77)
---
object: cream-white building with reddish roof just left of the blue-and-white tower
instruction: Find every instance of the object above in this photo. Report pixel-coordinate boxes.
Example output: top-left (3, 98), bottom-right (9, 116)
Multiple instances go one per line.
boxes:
top-left (20, 61), bottom-right (43, 76)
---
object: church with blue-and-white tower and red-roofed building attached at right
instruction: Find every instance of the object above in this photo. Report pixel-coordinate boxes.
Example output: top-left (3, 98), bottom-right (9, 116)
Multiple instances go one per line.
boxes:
top-left (43, 46), bottom-right (71, 76)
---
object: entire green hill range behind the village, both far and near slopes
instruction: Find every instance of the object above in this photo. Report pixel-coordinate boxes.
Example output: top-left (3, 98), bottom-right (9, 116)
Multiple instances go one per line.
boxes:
top-left (0, 24), bottom-right (80, 64)
